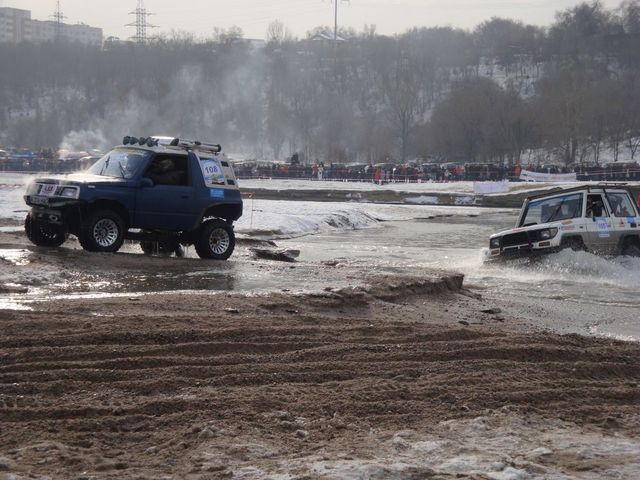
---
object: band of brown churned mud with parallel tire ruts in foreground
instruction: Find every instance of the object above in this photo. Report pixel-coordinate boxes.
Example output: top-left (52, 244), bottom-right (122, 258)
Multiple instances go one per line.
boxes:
top-left (0, 292), bottom-right (640, 476)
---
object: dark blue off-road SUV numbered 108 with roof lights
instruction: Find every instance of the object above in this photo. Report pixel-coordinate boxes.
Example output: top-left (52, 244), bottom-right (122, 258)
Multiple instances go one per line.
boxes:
top-left (24, 136), bottom-right (242, 260)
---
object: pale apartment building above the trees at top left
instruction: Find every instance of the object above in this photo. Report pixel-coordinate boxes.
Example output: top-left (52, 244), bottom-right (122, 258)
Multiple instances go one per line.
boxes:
top-left (0, 7), bottom-right (102, 47)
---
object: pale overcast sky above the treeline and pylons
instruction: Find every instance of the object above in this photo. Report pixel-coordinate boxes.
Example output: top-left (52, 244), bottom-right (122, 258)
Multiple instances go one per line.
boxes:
top-left (0, 0), bottom-right (621, 38)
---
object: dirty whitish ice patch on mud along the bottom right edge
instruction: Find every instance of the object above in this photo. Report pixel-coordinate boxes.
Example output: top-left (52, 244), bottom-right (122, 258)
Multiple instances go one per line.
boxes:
top-left (204, 412), bottom-right (640, 480)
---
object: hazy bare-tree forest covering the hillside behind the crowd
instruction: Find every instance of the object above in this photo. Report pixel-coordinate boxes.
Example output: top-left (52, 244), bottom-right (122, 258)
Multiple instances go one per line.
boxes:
top-left (0, 0), bottom-right (640, 165)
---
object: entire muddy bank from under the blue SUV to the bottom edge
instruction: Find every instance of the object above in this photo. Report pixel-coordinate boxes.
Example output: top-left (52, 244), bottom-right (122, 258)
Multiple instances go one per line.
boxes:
top-left (0, 234), bottom-right (640, 480)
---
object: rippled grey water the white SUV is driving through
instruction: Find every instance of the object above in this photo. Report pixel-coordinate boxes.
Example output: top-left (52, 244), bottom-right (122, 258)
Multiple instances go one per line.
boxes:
top-left (280, 210), bottom-right (640, 341)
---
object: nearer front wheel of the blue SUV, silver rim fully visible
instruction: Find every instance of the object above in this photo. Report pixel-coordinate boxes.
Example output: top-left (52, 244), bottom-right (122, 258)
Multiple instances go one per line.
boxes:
top-left (78, 210), bottom-right (126, 252)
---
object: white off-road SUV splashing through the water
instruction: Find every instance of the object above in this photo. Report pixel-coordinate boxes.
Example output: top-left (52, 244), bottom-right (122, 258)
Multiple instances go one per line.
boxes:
top-left (487, 184), bottom-right (640, 260)
